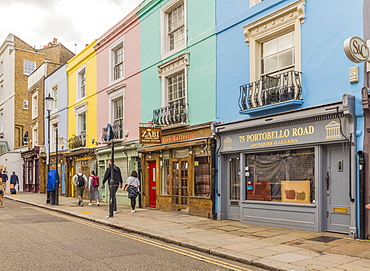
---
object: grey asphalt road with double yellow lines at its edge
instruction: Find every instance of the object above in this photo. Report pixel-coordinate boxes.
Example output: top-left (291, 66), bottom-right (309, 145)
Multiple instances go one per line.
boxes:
top-left (0, 200), bottom-right (263, 271)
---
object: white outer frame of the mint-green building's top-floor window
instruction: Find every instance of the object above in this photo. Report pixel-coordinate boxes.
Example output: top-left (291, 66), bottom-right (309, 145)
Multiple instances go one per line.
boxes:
top-left (161, 0), bottom-right (187, 59)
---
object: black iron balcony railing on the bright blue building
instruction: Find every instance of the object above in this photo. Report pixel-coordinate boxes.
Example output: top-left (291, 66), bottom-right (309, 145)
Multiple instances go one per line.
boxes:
top-left (239, 71), bottom-right (302, 111)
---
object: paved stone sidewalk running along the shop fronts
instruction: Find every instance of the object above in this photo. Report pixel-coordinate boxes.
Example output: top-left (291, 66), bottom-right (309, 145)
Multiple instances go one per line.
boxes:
top-left (5, 192), bottom-right (370, 271)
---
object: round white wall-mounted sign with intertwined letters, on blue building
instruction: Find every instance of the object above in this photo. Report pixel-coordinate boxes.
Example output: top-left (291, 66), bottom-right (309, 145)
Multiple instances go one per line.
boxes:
top-left (343, 36), bottom-right (369, 63)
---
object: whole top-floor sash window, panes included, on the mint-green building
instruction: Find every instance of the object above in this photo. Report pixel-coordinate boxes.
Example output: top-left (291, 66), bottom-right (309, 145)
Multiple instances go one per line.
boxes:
top-left (162, 0), bottom-right (186, 58)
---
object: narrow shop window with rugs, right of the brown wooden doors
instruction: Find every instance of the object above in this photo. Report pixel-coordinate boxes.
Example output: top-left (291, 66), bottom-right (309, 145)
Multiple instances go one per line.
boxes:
top-left (194, 156), bottom-right (211, 197)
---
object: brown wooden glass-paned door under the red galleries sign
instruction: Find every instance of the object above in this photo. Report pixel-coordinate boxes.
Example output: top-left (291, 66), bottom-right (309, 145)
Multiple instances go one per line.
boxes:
top-left (171, 159), bottom-right (189, 211)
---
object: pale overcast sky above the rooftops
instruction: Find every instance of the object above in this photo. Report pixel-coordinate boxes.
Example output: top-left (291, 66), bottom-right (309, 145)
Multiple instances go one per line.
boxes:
top-left (0, 0), bottom-right (142, 53)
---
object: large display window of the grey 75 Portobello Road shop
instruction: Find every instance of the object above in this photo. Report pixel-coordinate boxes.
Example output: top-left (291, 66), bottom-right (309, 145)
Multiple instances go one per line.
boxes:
top-left (245, 148), bottom-right (315, 203)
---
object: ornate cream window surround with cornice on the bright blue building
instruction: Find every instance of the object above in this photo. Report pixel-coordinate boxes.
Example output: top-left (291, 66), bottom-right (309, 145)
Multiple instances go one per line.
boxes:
top-left (244, 0), bottom-right (305, 82)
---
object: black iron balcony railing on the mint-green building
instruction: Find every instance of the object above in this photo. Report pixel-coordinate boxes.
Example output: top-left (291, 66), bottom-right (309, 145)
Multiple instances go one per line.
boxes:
top-left (152, 103), bottom-right (188, 125)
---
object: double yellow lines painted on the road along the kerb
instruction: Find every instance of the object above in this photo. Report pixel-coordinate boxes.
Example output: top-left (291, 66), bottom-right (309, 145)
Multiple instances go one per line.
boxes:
top-left (32, 207), bottom-right (252, 271)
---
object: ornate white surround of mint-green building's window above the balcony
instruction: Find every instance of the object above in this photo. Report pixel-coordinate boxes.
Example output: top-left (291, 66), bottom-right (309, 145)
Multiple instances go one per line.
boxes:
top-left (158, 54), bottom-right (189, 107)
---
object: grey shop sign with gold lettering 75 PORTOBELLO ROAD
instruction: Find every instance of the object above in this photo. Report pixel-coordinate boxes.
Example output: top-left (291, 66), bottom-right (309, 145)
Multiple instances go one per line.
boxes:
top-left (222, 120), bottom-right (344, 151)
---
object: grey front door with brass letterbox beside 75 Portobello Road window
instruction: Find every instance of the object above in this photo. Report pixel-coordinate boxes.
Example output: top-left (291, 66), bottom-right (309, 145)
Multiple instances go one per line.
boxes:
top-left (325, 146), bottom-right (351, 233)
